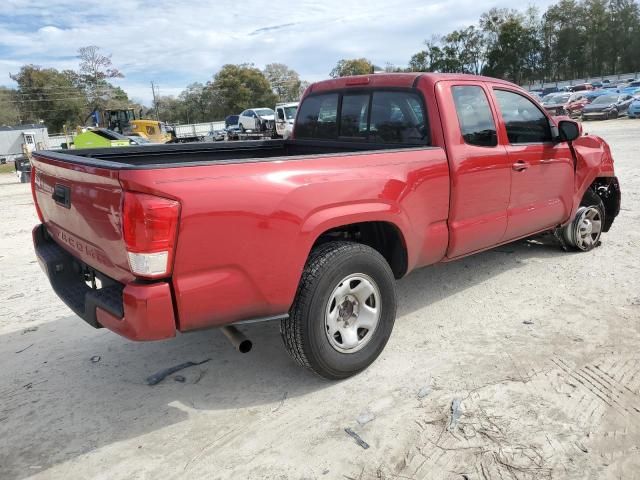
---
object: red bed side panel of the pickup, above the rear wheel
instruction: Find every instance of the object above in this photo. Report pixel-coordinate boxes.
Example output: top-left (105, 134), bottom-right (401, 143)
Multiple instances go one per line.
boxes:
top-left (120, 148), bottom-right (449, 330)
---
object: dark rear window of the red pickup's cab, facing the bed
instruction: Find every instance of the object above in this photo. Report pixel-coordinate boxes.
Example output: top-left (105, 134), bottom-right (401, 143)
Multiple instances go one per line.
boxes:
top-left (295, 89), bottom-right (430, 146)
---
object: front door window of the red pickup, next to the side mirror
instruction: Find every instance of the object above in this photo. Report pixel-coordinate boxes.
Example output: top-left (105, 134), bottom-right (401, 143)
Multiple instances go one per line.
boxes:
top-left (494, 89), bottom-right (551, 144)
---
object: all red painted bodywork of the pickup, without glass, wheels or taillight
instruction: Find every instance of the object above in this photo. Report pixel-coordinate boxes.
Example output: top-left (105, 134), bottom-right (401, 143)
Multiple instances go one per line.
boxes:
top-left (34, 74), bottom-right (613, 339)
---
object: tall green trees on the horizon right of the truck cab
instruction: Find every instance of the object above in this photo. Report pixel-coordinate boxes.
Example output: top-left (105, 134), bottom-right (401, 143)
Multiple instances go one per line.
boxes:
top-left (331, 0), bottom-right (640, 85)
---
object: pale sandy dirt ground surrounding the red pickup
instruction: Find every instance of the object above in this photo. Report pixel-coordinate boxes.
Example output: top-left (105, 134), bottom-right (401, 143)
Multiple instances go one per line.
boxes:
top-left (0, 119), bottom-right (640, 480)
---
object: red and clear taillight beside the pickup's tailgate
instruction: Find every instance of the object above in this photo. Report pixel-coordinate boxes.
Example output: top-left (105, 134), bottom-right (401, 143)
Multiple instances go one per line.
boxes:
top-left (122, 192), bottom-right (180, 278)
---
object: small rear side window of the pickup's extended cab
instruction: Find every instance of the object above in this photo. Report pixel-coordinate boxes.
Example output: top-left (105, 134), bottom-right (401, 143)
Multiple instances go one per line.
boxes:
top-left (451, 85), bottom-right (498, 147)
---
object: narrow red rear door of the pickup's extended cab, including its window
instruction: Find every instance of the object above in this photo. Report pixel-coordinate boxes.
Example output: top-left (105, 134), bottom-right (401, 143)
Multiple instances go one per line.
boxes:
top-left (437, 82), bottom-right (511, 258)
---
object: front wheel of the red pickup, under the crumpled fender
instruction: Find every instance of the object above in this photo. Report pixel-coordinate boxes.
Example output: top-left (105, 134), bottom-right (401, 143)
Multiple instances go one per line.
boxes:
top-left (561, 190), bottom-right (605, 252)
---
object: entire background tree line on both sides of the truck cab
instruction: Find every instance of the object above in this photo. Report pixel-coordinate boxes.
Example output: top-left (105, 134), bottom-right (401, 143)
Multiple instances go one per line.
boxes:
top-left (0, 0), bottom-right (640, 132)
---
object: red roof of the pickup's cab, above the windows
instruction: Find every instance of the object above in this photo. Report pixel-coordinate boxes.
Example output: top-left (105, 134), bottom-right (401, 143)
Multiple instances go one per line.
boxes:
top-left (307, 72), bottom-right (520, 94)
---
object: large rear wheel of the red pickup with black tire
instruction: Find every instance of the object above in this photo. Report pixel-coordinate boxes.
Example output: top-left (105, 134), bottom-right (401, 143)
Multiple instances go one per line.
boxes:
top-left (280, 242), bottom-right (396, 380)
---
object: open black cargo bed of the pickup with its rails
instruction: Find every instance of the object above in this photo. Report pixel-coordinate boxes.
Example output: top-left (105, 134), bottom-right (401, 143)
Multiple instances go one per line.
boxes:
top-left (38, 140), bottom-right (429, 170)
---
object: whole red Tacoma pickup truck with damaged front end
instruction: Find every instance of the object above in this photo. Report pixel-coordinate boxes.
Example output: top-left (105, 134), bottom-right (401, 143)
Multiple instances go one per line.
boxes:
top-left (31, 73), bottom-right (620, 379)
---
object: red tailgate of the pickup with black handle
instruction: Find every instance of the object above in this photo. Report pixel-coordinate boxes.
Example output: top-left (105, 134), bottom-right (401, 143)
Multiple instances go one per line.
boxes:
top-left (33, 154), bottom-right (134, 283)
